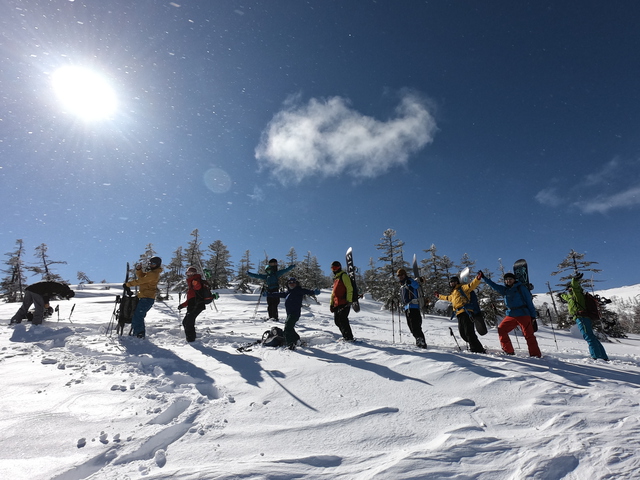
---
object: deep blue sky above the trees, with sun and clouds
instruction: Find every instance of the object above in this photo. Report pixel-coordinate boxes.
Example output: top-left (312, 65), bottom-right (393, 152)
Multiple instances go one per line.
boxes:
top-left (0, 0), bottom-right (640, 290)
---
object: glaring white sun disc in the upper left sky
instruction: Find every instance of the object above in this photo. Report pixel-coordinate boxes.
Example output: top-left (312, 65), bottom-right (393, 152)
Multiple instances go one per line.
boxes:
top-left (51, 67), bottom-right (117, 120)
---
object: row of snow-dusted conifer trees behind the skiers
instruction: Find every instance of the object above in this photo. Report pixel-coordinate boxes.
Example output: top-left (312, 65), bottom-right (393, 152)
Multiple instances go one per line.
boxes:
top-left (0, 229), bottom-right (640, 336)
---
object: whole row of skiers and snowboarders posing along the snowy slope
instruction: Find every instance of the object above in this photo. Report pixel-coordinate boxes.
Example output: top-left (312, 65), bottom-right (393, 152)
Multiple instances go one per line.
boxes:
top-left (11, 257), bottom-right (609, 360)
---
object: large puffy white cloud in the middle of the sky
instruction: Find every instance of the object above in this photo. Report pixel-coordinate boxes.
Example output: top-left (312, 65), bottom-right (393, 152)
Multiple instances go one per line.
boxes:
top-left (256, 93), bottom-right (437, 182)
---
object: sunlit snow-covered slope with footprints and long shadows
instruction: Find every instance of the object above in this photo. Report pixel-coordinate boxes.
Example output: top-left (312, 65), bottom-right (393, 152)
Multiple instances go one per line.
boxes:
top-left (0, 285), bottom-right (640, 480)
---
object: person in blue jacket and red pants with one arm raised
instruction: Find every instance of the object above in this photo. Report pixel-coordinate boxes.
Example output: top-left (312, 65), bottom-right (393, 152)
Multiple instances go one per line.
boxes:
top-left (478, 272), bottom-right (542, 358)
